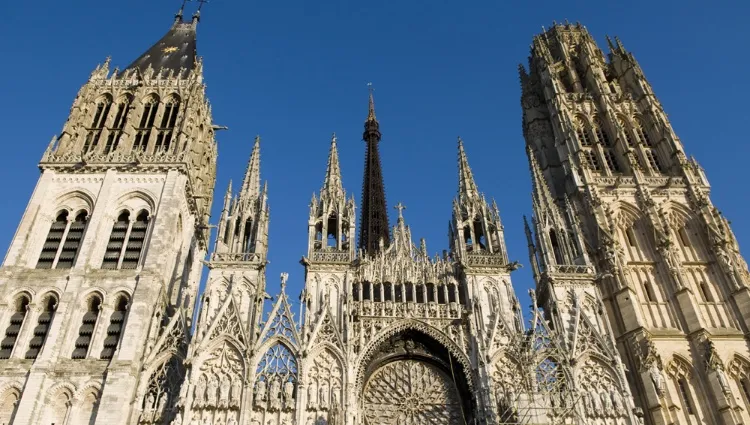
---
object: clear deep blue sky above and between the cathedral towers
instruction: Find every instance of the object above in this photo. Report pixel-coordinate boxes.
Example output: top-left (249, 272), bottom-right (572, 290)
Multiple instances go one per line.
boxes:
top-left (0, 0), bottom-right (750, 318)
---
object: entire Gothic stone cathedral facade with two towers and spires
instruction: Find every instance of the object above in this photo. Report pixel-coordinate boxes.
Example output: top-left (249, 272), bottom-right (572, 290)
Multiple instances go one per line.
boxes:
top-left (0, 5), bottom-right (750, 425)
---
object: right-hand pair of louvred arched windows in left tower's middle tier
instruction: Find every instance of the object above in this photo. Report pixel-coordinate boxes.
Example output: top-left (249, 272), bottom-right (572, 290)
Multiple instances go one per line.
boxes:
top-left (102, 210), bottom-right (149, 269)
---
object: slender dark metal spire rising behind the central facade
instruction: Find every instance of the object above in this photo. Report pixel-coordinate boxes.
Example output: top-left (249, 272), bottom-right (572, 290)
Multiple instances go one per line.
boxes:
top-left (359, 84), bottom-right (390, 255)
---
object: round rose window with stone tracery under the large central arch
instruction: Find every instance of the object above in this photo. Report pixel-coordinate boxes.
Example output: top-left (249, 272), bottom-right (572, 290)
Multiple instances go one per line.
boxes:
top-left (364, 359), bottom-right (463, 425)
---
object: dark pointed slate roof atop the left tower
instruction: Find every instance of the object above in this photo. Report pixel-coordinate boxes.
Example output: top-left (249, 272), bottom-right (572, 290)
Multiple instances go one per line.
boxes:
top-left (127, 9), bottom-right (200, 75)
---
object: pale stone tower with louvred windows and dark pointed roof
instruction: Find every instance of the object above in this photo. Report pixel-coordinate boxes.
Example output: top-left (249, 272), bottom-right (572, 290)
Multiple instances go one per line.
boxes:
top-left (0, 10), bottom-right (217, 425)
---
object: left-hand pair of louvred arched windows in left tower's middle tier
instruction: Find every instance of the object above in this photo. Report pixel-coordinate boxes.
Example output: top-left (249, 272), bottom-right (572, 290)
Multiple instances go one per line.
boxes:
top-left (36, 210), bottom-right (88, 269)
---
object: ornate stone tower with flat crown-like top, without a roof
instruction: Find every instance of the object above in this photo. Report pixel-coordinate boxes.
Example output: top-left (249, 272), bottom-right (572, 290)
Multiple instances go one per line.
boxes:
top-left (519, 23), bottom-right (750, 425)
